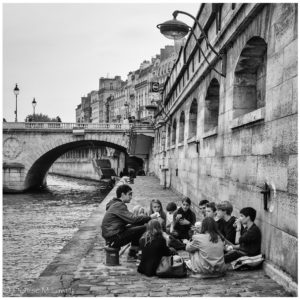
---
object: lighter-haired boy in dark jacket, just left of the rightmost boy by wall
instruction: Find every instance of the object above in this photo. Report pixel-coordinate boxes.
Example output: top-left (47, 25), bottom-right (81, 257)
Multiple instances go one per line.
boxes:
top-left (217, 201), bottom-right (236, 244)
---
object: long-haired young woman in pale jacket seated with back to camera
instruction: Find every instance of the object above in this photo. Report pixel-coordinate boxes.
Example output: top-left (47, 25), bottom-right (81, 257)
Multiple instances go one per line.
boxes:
top-left (184, 217), bottom-right (226, 278)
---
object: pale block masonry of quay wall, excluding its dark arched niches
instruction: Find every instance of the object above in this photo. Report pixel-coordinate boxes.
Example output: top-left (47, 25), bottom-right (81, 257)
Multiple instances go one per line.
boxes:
top-left (154, 3), bottom-right (298, 281)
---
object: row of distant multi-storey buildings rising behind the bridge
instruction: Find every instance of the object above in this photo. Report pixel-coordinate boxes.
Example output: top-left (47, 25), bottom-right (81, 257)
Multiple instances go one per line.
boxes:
top-left (76, 40), bottom-right (179, 123)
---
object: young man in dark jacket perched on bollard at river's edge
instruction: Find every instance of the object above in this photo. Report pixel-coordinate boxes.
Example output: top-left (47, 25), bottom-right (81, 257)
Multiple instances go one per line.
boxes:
top-left (101, 184), bottom-right (158, 261)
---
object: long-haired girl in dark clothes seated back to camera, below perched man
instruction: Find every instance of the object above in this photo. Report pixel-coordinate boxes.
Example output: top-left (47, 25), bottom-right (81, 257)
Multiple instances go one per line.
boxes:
top-left (138, 220), bottom-right (174, 276)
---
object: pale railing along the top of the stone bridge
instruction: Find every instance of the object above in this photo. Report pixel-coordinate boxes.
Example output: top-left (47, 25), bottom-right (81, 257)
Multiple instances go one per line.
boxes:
top-left (2, 122), bottom-right (132, 130)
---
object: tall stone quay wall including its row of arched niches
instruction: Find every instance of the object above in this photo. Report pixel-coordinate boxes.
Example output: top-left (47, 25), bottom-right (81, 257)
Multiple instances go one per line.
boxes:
top-left (153, 3), bottom-right (298, 281)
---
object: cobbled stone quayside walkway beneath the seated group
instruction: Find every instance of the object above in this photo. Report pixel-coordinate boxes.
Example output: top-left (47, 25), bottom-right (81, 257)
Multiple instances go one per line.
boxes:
top-left (25, 176), bottom-right (290, 297)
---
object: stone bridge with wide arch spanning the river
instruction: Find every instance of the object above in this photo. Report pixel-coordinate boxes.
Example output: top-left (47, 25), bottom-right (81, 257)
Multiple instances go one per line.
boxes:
top-left (3, 122), bottom-right (153, 192)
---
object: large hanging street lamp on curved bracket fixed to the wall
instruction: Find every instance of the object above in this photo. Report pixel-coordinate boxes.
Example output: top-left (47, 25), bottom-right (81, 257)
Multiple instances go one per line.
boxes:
top-left (157, 10), bottom-right (225, 77)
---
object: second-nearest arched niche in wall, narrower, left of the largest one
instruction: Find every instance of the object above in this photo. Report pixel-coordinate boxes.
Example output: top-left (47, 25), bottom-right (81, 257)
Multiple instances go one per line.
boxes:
top-left (204, 78), bottom-right (220, 131)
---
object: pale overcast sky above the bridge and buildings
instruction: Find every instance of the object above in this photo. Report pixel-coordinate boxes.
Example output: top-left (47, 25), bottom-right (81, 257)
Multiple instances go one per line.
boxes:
top-left (3, 2), bottom-right (200, 122)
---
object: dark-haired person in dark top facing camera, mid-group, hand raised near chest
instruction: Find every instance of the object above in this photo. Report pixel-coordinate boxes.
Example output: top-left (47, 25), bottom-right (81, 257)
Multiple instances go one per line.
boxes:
top-left (172, 197), bottom-right (196, 240)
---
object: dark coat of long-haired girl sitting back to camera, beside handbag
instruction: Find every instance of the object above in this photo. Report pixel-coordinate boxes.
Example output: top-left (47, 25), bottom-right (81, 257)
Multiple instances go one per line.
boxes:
top-left (138, 236), bottom-right (172, 276)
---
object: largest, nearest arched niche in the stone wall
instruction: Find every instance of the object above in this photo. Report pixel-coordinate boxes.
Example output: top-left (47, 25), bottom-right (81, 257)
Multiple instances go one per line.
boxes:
top-left (233, 36), bottom-right (267, 118)
